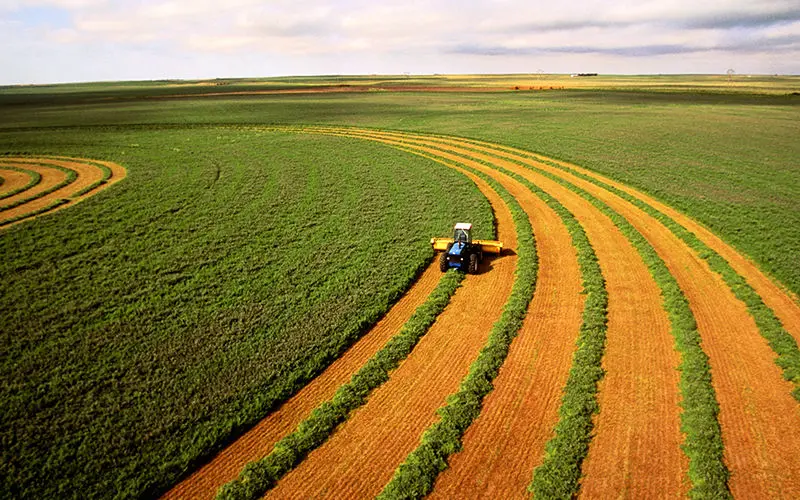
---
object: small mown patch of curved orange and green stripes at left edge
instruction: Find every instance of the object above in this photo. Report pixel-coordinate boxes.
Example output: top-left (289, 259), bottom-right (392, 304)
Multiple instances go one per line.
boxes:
top-left (0, 156), bottom-right (126, 228)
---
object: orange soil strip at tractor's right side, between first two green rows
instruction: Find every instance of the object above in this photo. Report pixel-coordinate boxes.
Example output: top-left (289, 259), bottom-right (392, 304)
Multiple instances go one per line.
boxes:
top-left (267, 163), bottom-right (516, 498)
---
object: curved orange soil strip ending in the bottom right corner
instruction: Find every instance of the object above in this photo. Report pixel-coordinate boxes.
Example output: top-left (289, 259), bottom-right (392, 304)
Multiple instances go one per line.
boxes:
top-left (334, 130), bottom-right (800, 497)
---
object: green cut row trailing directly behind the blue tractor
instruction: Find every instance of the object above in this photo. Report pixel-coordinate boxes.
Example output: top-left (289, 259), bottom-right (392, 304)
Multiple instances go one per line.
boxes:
top-left (217, 271), bottom-right (464, 499)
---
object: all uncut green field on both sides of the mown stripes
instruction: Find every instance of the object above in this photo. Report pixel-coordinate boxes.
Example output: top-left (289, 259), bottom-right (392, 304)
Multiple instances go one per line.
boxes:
top-left (0, 76), bottom-right (800, 498)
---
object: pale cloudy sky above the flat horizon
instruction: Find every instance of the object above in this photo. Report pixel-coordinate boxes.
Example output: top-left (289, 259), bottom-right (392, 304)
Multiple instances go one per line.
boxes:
top-left (0, 0), bottom-right (800, 85)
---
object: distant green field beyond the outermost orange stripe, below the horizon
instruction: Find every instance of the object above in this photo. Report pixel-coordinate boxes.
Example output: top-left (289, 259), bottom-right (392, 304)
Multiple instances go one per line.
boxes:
top-left (0, 84), bottom-right (800, 295)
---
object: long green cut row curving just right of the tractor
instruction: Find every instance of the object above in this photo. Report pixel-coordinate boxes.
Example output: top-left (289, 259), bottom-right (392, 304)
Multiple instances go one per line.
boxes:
top-left (379, 153), bottom-right (538, 499)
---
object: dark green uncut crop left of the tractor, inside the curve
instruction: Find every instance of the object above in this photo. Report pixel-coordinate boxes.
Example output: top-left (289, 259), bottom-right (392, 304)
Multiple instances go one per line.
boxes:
top-left (0, 127), bottom-right (491, 498)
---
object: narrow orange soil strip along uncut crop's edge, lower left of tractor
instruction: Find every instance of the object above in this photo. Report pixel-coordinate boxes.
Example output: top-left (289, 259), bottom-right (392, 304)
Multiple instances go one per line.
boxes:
top-left (163, 261), bottom-right (441, 499)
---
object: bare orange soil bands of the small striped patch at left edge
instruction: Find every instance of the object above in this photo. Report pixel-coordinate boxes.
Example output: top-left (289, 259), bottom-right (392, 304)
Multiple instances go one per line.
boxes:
top-left (0, 157), bottom-right (126, 227)
